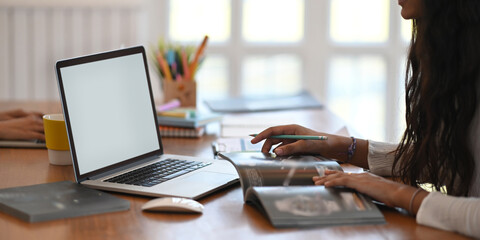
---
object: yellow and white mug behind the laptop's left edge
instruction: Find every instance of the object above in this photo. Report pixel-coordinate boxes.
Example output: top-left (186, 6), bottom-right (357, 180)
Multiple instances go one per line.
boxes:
top-left (43, 113), bottom-right (72, 165)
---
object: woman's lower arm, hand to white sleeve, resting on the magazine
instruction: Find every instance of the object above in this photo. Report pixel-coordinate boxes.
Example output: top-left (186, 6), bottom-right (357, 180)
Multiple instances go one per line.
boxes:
top-left (313, 170), bottom-right (480, 238)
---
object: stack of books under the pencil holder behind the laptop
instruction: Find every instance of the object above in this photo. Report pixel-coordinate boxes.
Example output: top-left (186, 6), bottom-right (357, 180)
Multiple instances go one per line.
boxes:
top-left (157, 108), bottom-right (222, 138)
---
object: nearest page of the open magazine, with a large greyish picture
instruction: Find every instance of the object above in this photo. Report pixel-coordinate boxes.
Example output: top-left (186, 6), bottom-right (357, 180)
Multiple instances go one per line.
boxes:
top-left (246, 186), bottom-right (385, 228)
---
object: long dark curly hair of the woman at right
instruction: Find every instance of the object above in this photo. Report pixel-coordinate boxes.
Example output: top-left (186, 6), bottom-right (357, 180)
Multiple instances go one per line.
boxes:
top-left (392, 0), bottom-right (480, 196)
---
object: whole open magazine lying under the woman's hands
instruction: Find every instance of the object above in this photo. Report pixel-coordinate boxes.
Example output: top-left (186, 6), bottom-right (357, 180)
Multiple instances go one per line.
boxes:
top-left (219, 152), bottom-right (385, 228)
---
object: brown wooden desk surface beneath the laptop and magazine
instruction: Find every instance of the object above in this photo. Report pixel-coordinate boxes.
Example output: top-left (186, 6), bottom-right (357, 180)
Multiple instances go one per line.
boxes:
top-left (0, 102), bottom-right (466, 240)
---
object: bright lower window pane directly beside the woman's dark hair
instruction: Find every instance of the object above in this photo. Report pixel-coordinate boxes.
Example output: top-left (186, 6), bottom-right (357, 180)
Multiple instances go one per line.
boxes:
top-left (327, 55), bottom-right (387, 139)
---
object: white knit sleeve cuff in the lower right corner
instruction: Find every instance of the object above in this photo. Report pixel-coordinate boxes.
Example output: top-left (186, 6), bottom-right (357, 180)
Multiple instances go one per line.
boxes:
top-left (417, 192), bottom-right (480, 238)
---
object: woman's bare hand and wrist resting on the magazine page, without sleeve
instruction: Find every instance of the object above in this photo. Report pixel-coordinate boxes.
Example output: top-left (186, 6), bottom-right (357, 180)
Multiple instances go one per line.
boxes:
top-left (313, 170), bottom-right (428, 213)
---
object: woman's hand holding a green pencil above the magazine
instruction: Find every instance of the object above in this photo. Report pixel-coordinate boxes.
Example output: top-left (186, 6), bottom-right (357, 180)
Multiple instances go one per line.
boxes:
top-left (251, 124), bottom-right (352, 159)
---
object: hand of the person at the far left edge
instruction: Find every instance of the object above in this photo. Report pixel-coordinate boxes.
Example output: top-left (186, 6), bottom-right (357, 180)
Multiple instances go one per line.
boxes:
top-left (0, 110), bottom-right (45, 140)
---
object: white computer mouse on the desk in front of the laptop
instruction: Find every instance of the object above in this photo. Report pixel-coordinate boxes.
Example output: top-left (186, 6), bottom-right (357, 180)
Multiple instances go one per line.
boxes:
top-left (142, 197), bottom-right (203, 213)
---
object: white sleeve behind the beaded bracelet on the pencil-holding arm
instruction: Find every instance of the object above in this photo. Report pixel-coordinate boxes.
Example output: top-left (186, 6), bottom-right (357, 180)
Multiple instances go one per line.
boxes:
top-left (367, 140), bottom-right (398, 176)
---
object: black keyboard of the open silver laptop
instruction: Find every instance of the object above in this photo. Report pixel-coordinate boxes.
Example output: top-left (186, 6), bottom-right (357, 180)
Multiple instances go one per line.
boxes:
top-left (104, 158), bottom-right (212, 187)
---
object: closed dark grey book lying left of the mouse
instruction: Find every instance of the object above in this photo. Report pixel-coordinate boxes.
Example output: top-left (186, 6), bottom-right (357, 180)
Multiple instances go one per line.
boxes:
top-left (0, 181), bottom-right (130, 222)
